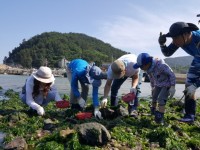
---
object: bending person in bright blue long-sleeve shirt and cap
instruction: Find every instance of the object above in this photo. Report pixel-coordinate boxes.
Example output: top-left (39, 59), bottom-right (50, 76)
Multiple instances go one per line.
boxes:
top-left (66, 59), bottom-right (107, 118)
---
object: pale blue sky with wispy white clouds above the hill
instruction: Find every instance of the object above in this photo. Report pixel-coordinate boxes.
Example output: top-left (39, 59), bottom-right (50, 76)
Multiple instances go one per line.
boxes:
top-left (0, 0), bottom-right (200, 63)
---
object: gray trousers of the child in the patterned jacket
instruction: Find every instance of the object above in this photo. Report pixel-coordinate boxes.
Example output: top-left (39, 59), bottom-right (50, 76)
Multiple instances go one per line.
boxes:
top-left (152, 86), bottom-right (169, 106)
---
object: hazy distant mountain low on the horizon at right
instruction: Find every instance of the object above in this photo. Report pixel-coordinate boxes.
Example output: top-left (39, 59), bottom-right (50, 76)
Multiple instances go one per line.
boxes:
top-left (164, 56), bottom-right (193, 67)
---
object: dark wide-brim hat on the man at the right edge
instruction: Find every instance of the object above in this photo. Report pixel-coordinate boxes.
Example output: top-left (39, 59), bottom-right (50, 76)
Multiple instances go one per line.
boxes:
top-left (165, 22), bottom-right (199, 37)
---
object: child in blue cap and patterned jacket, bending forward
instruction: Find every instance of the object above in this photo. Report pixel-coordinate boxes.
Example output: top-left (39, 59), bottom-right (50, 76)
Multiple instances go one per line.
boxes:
top-left (133, 53), bottom-right (176, 123)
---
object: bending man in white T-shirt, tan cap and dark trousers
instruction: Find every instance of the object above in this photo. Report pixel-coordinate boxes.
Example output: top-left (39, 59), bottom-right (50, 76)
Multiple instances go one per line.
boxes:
top-left (101, 54), bottom-right (140, 115)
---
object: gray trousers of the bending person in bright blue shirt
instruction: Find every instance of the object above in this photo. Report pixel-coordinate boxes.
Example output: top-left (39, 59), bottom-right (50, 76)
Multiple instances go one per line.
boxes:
top-left (66, 68), bottom-right (89, 104)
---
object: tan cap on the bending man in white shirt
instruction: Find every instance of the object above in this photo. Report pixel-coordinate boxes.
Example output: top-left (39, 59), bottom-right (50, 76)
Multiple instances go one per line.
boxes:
top-left (111, 60), bottom-right (126, 79)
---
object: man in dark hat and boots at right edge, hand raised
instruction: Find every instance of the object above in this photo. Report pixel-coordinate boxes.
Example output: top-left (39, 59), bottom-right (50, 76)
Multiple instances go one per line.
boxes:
top-left (158, 22), bottom-right (200, 122)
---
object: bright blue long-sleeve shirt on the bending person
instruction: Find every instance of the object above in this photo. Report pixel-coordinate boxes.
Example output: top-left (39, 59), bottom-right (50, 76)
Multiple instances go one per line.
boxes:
top-left (68, 59), bottom-right (99, 106)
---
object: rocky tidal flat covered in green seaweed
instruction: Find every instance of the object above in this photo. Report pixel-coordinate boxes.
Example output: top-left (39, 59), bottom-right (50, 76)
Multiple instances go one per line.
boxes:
top-left (0, 89), bottom-right (200, 150)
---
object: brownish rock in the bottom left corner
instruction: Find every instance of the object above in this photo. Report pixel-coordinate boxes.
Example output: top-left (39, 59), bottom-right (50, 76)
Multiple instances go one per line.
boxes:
top-left (4, 137), bottom-right (28, 150)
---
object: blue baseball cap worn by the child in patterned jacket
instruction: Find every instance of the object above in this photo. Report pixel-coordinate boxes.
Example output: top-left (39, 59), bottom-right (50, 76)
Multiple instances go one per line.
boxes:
top-left (133, 53), bottom-right (153, 69)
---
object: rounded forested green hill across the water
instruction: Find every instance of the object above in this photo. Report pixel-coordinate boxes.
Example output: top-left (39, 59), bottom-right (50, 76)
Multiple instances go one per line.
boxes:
top-left (4, 32), bottom-right (127, 68)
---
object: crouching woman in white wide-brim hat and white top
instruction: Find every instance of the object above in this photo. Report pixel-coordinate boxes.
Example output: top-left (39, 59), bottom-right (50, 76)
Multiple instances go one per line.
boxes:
top-left (20, 66), bottom-right (61, 116)
